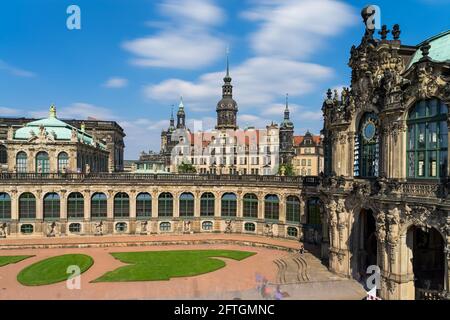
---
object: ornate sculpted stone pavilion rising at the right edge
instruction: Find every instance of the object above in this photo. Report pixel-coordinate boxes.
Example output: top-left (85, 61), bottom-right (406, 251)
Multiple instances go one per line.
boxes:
top-left (320, 9), bottom-right (450, 299)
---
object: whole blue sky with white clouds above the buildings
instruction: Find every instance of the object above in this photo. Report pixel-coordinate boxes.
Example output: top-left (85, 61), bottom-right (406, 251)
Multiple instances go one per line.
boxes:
top-left (0, 0), bottom-right (450, 159)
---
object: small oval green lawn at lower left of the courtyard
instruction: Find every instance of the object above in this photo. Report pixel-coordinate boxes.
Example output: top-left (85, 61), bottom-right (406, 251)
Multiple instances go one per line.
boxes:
top-left (17, 254), bottom-right (94, 286)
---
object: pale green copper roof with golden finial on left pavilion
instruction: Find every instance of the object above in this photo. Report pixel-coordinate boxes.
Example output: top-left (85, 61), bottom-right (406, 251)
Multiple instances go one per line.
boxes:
top-left (14, 106), bottom-right (106, 150)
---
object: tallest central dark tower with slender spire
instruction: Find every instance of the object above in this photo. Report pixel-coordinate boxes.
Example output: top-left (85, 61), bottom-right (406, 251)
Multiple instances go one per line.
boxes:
top-left (216, 55), bottom-right (238, 130)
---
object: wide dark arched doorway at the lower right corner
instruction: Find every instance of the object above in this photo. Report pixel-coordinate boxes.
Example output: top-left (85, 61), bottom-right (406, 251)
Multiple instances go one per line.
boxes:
top-left (406, 226), bottom-right (446, 300)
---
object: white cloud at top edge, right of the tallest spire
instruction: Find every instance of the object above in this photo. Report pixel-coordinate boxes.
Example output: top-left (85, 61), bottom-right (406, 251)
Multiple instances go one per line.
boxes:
top-left (242, 0), bottom-right (358, 58)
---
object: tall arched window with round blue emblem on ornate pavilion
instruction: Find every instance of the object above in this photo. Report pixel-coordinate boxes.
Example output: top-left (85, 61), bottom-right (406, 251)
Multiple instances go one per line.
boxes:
top-left (354, 113), bottom-right (380, 178)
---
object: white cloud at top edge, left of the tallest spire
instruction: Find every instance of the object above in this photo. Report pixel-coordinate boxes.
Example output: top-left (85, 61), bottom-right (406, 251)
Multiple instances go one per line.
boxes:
top-left (122, 0), bottom-right (226, 69)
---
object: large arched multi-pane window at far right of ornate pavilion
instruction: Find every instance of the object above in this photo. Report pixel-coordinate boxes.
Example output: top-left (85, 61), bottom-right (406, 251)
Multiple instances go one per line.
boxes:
top-left (407, 99), bottom-right (448, 179)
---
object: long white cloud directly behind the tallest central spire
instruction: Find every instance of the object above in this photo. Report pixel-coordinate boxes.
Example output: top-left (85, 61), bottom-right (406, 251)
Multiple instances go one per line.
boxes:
top-left (144, 57), bottom-right (333, 112)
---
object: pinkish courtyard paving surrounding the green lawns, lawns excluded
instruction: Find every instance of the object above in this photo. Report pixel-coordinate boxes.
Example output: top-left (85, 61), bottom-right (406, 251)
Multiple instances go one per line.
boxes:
top-left (0, 234), bottom-right (364, 300)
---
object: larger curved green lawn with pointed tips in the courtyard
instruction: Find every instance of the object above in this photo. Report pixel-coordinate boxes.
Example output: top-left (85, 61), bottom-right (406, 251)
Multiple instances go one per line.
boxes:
top-left (94, 250), bottom-right (255, 282)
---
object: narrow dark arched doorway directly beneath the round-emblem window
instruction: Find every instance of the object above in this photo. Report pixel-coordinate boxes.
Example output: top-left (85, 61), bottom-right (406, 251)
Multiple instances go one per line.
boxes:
top-left (353, 209), bottom-right (378, 280)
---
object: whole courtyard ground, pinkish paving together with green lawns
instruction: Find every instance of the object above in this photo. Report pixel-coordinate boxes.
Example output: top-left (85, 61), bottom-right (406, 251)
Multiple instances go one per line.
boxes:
top-left (0, 235), bottom-right (365, 300)
